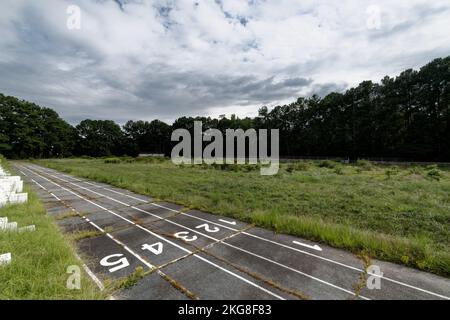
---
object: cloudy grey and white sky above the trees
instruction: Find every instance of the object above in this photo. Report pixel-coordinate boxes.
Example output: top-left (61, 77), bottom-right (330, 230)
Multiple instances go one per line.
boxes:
top-left (0, 0), bottom-right (450, 124)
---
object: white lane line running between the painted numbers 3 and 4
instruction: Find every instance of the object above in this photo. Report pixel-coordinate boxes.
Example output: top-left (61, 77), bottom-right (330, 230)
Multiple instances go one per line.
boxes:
top-left (21, 168), bottom-right (286, 300)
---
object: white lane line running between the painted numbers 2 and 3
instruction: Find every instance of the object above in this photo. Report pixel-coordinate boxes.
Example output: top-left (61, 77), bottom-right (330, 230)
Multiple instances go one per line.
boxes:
top-left (30, 170), bottom-right (369, 300)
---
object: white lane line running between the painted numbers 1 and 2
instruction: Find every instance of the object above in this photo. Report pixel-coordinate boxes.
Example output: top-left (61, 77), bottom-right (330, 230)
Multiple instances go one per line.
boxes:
top-left (29, 164), bottom-right (450, 300)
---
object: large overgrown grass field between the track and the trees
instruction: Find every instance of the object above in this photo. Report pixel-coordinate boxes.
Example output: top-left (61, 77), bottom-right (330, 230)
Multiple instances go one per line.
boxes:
top-left (38, 158), bottom-right (450, 277)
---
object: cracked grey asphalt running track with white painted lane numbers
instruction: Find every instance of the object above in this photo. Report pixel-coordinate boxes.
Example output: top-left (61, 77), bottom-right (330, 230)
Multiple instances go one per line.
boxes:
top-left (14, 163), bottom-right (450, 300)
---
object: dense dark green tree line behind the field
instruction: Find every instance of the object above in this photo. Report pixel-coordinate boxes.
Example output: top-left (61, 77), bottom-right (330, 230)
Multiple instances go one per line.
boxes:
top-left (0, 57), bottom-right (450, 161)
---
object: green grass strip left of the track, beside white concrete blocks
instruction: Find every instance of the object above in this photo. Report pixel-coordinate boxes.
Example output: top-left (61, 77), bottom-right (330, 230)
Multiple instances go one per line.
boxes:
top-left (0, 161), bottom-right (105, 300)
